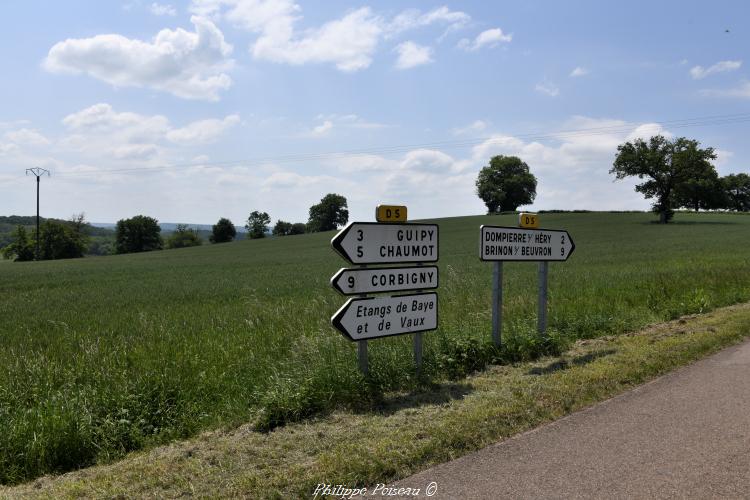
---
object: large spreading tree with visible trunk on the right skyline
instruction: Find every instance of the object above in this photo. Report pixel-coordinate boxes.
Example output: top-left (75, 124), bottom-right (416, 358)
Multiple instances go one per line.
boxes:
top-left (609, 135), bottom-right (716, 224)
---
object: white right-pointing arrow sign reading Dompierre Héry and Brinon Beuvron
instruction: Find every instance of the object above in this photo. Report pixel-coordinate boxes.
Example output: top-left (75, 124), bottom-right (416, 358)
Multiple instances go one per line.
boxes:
top-left (479, 226), bottom-right (576, 261)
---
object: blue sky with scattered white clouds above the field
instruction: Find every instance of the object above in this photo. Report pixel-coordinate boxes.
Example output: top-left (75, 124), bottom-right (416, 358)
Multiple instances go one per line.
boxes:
top-left (0, 0), bottom-right (750, 225)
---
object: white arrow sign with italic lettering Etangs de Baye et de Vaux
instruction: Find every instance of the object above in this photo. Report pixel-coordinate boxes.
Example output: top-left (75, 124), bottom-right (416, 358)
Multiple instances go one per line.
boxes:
top-left (331, 292), bottom-right (438, 341)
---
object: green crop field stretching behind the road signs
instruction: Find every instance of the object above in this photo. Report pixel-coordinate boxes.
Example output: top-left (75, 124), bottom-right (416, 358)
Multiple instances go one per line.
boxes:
top-left (0, 213), bottom-right (750, 483)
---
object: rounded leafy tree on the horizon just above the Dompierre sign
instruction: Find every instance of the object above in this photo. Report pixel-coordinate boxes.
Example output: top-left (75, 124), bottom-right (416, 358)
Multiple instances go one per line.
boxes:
top-left (476, 155), bottom-right (536, 214)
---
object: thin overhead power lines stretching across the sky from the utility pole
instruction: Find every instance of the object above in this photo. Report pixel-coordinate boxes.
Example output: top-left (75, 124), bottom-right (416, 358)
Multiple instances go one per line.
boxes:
top-left (26, 113), bottom-right (750, 177)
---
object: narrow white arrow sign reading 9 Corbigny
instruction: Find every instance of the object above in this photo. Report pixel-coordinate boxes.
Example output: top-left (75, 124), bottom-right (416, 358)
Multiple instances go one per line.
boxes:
top-left (331, 266), bottom-right (438, 295)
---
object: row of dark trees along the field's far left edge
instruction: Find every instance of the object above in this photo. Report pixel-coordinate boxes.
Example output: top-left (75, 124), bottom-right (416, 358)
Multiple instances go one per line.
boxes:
top-left (2, 193), bottom-right (349, 261)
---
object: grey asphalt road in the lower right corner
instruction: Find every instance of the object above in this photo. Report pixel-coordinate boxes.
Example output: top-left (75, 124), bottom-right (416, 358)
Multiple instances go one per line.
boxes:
top-left (396, 342), bottom-right (750, 499)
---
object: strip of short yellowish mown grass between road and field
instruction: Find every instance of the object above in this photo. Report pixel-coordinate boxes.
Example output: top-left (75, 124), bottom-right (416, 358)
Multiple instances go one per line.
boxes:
top-left (5, 304), bottom-right (750, 498)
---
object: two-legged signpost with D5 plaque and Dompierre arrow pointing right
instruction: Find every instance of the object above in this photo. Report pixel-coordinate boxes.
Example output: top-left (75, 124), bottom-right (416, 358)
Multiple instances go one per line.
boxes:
top-left (479, 225), bottom-right (575, 346)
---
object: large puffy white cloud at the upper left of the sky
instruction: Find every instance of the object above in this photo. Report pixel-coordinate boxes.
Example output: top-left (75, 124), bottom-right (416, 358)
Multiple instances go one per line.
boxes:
top-left (44, 16), bottom-right (232, 101)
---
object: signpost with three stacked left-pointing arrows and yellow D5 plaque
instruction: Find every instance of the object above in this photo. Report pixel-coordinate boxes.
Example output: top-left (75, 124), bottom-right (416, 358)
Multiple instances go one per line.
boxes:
top-left (331, 205), bottom-right (439, 374)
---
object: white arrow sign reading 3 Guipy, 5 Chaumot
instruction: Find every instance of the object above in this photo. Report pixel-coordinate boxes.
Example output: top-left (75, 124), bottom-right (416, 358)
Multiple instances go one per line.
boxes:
top-left (331, 222), bottom-right (438, 264)
